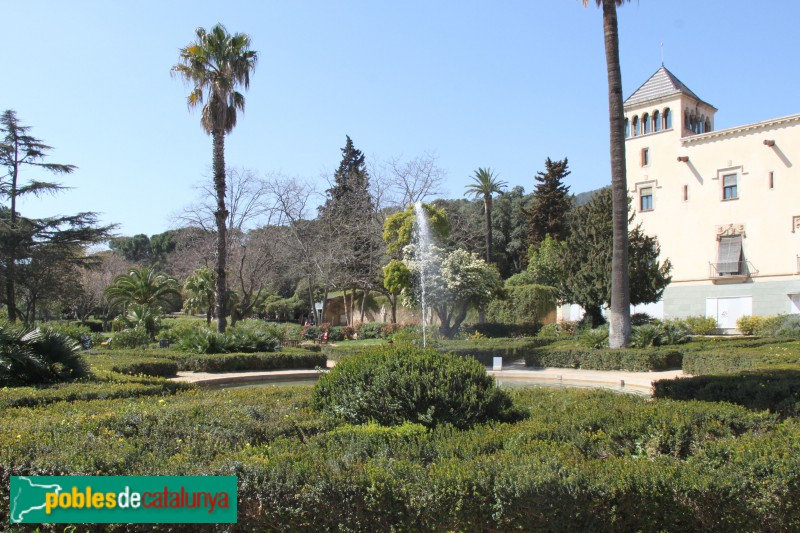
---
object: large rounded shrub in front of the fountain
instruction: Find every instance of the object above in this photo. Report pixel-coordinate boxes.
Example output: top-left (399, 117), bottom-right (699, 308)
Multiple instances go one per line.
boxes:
top-left (311, 345), bottom-right (521, 428)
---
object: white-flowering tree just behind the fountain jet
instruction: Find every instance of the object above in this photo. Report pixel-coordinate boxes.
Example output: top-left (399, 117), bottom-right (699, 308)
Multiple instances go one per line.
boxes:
top-left (404, 246), bottom-right (503, 339)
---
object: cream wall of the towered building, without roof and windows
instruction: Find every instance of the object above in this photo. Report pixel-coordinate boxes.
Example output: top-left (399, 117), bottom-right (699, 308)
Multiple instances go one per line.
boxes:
top-left (626, 96), bottom-right (800, 285)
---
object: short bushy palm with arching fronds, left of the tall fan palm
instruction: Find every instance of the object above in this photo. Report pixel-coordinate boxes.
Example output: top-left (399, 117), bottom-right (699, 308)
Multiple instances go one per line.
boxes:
top-left (105, 267), bottom-right (181, 309)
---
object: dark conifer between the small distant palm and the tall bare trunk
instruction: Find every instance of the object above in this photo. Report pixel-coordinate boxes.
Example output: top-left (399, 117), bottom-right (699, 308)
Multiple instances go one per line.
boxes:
top-left (525, 157), bottom-right (571, 246)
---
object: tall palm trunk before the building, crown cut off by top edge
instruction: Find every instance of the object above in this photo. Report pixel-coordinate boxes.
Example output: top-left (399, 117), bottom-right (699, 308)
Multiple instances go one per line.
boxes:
top-left (583, 0), bottom-right (631, 348)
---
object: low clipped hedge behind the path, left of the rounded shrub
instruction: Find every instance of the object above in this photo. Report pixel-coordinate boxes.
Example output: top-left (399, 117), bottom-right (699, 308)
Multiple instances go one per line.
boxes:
top-left (181, 350), bottom-right (327, 372)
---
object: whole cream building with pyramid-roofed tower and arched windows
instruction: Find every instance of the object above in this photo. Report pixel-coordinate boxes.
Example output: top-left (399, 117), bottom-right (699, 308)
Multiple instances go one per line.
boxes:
top-left (625, 66), bottom-right (800, 329)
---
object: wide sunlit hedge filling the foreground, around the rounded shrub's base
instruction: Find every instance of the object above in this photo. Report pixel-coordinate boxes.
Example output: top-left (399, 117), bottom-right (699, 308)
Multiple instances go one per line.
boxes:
top-left (0, 388), bottom-right (800, 532)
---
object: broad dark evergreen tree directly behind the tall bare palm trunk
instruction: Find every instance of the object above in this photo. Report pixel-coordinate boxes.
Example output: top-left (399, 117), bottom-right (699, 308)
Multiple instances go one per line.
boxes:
top-left (560, 187), bottom-right (672, 327)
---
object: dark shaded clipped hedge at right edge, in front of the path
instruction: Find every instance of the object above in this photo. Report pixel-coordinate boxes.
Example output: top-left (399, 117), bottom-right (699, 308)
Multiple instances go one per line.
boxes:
top-left (654, 369), bottom-right (800, 417)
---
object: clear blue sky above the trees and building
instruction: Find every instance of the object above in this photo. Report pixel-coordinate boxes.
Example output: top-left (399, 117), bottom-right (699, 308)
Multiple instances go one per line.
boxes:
top-left (0, 0), bottom-right (800, 235)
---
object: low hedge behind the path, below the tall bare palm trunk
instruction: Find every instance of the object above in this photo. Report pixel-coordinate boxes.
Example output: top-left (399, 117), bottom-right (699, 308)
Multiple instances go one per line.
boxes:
top-left (525, 341), bottom-right (683, 372)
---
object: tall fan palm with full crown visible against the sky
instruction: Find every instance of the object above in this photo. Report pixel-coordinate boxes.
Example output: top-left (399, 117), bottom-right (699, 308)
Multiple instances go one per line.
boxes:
top-left (172, 24), bottom-right (258, 333)
